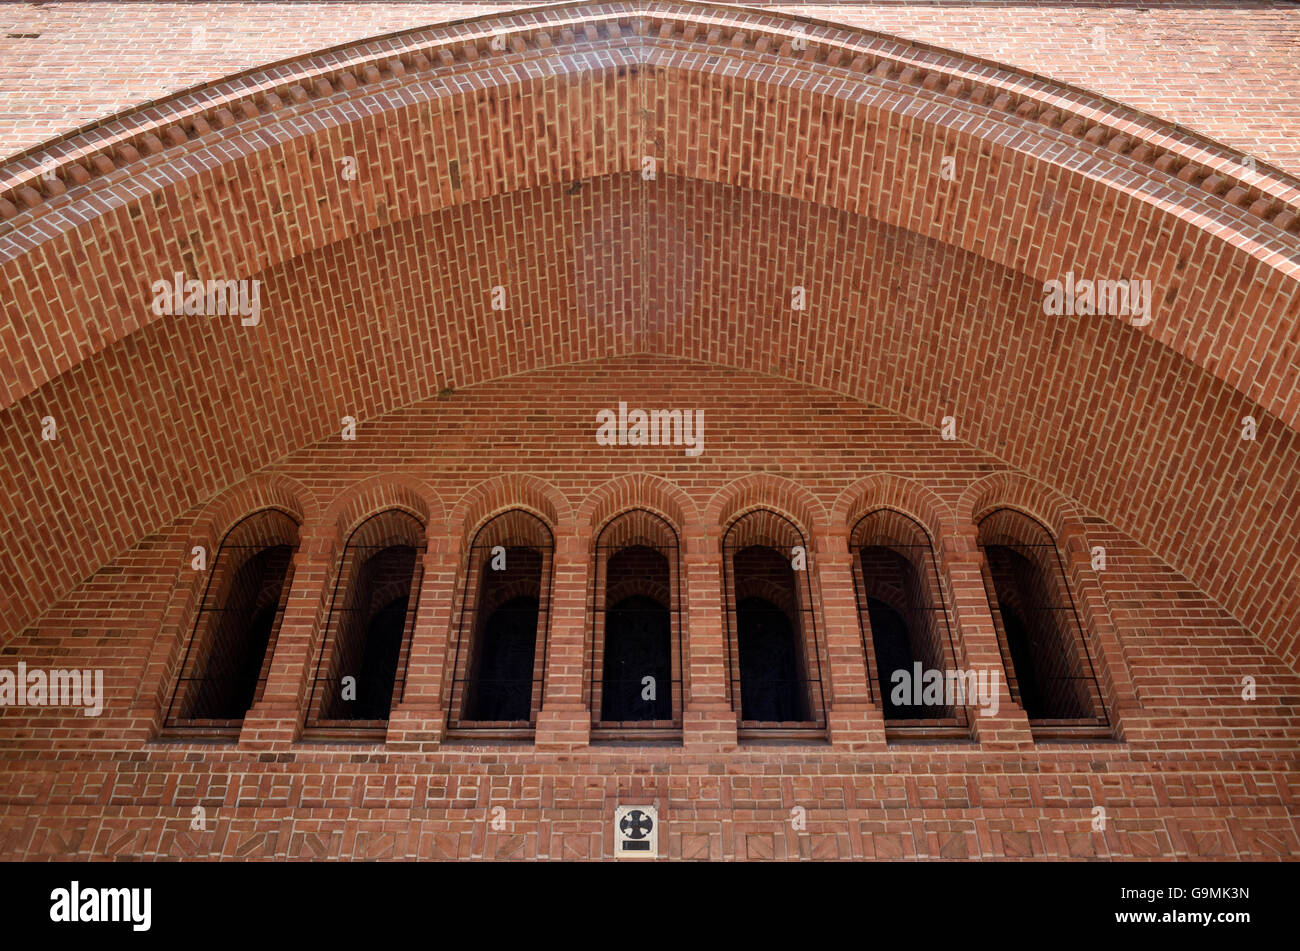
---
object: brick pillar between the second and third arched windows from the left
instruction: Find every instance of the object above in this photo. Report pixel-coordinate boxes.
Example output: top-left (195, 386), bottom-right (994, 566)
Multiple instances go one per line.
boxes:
top-left (386, 535), bottom-right (462, 751)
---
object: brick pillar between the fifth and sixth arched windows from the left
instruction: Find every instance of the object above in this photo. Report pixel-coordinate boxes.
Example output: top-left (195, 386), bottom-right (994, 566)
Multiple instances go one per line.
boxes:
top-left (814, 531), bottom-right (887, 751)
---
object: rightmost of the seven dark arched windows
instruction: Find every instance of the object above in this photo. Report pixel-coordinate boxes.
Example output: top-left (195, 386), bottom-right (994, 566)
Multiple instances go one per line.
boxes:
top-left (979, 509), bottom-right (1109, 734)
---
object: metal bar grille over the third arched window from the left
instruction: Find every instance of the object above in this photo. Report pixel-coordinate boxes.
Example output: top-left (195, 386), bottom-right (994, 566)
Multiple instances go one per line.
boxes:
top-left (447, 509), bottom-right (555, 739)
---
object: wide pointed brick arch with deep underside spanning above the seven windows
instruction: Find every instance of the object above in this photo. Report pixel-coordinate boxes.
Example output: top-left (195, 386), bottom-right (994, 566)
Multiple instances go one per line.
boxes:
top-left (0, 5), bottom-right (1300, 665)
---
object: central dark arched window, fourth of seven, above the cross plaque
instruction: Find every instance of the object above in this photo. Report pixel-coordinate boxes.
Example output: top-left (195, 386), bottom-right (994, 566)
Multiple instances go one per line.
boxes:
top-left (590, 509), bottom-right (683, 738)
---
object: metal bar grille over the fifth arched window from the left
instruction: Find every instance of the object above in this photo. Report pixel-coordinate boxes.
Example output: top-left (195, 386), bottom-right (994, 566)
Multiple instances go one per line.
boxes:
top-left (723, 508), bottom-right (827, 739)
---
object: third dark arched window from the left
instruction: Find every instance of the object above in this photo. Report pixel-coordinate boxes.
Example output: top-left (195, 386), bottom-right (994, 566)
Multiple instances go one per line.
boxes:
top-left (450, 509), bottom-right (555, 734)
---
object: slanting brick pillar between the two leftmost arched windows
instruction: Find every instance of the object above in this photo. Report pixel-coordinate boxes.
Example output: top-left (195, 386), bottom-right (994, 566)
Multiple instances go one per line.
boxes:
top-left (239, 526), bottom-right (341, 750)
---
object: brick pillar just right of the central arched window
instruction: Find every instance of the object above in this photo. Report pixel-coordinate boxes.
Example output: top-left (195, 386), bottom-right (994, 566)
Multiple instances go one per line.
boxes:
top-left (681, 525), bottom-right (738, 752)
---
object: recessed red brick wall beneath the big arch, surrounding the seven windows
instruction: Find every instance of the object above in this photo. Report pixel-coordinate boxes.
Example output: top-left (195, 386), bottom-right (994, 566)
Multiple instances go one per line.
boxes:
top-left (0, 356), bottom-right (1300, 859)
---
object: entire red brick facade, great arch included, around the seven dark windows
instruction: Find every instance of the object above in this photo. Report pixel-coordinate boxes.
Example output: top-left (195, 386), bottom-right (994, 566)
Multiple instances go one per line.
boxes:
top-left (0, 4), bottom-right (1300, 859)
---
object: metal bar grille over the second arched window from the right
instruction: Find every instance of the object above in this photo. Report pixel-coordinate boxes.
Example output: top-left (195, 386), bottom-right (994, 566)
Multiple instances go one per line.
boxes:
top-left (849, 509), bottom-right (971, 739)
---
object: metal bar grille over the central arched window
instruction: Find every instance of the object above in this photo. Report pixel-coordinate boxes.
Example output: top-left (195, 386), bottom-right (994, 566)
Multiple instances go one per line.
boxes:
top-left (588, 508), bottom-right (685, 739)
